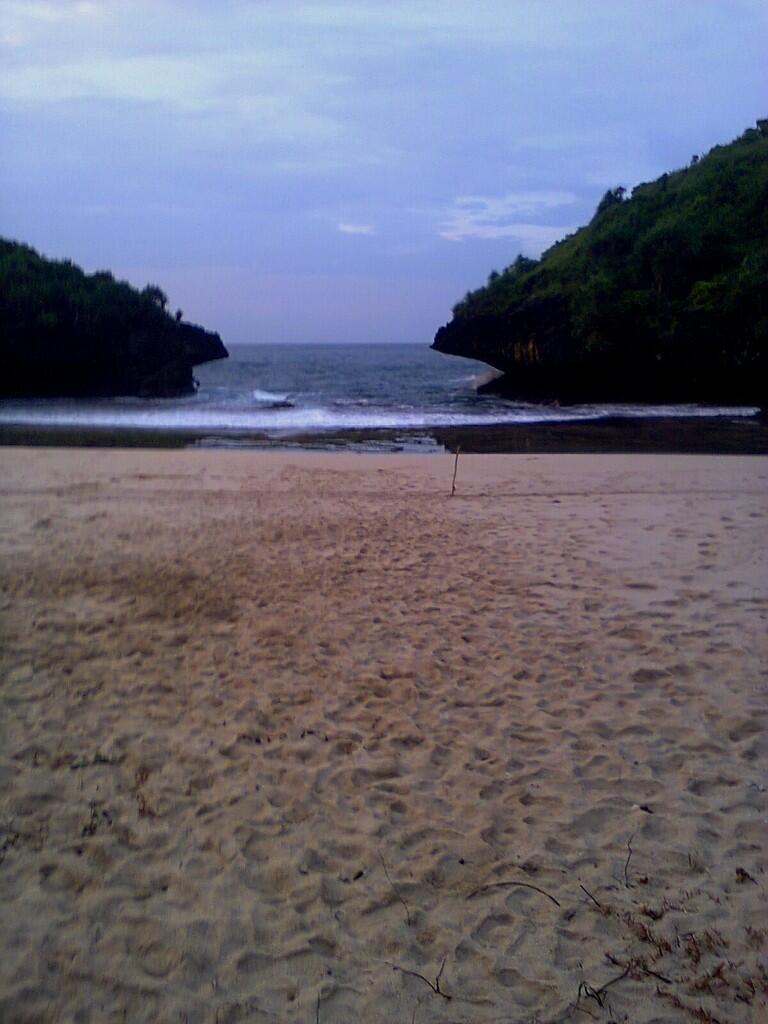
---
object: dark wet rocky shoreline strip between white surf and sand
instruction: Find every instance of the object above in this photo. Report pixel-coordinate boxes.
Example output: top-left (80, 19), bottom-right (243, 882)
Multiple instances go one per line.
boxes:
top-left (0, 416), bottom-right (768, 455)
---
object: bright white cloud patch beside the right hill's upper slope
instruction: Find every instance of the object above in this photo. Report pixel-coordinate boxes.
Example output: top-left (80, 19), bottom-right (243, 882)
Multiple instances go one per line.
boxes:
top-left (438, 190), bottom-right (578, 252)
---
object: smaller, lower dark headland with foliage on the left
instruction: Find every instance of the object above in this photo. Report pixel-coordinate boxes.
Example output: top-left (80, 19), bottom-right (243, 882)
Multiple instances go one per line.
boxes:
top-left (0, 239), bottom-right (226, 394)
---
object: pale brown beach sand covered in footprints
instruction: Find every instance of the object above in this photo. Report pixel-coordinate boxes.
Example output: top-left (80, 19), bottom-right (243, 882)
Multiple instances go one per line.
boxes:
top-left (0, 449), bottom-right (768, 1024)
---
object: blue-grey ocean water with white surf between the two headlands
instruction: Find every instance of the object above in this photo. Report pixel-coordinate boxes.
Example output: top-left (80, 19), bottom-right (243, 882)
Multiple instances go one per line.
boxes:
top-left (0, 344), bottom-right (757, 451)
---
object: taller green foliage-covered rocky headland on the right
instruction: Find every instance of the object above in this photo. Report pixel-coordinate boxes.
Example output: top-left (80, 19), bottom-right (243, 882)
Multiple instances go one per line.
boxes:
top-left (435, 121), bottom-right (768, 402)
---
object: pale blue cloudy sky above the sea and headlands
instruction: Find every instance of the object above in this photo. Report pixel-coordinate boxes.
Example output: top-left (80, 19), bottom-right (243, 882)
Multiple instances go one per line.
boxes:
top-left (0, 0), bottom-right (768, 344)
